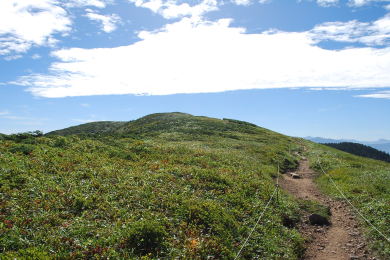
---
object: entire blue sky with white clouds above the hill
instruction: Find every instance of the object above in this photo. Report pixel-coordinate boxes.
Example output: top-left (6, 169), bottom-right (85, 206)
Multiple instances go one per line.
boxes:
top-left (0, 0), bottom-right (390, 140)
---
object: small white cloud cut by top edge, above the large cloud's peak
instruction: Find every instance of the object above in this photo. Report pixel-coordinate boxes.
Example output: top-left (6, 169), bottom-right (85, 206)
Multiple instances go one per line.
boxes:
top-left (128, 0), bottom-right (218, 19)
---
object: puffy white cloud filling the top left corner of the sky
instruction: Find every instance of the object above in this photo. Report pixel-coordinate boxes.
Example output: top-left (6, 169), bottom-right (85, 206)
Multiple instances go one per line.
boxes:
top-left (0, 0), bottom-right (71, 55)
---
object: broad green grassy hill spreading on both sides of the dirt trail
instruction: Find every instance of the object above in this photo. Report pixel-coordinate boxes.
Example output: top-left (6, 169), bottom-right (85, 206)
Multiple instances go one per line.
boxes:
top-left (0, 113), bottom-right (390, 259)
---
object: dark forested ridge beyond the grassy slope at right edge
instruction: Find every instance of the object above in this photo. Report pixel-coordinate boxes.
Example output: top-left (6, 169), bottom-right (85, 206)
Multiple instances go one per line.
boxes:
top-left (325, 142), bottom-right (390, 162)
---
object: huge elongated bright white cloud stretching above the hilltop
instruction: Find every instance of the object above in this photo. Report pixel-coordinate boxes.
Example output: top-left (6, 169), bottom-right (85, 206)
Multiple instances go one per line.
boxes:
top-left (10, 18), bottom-right (390, 98)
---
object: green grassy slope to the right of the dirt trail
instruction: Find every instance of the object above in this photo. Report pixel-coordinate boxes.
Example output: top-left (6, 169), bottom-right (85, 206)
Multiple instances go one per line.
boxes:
top-left (305, 142), bottom-right (390, 259)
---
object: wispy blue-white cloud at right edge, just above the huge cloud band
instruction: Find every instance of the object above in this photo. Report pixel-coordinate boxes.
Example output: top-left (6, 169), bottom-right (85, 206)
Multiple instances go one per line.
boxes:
top-left (311, 14), bottom-right (390, 45)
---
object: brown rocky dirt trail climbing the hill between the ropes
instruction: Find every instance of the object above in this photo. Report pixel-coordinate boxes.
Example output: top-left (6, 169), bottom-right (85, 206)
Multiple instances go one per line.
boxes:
top-left (280, 159), bottom-right (376, 260)
